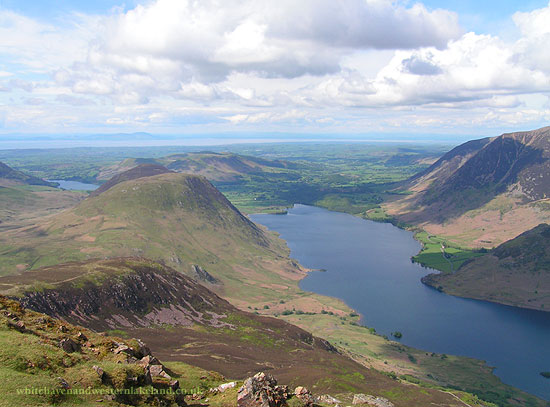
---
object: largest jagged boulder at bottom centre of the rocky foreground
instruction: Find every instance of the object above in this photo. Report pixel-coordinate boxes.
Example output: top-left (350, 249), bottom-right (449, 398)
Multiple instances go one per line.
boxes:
top-left (237, 372), bottom-right (286, 407)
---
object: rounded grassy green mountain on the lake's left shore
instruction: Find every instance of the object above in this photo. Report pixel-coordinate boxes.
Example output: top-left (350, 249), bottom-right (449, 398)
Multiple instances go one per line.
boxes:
top-left (0, 167), bottom-right (304, 305)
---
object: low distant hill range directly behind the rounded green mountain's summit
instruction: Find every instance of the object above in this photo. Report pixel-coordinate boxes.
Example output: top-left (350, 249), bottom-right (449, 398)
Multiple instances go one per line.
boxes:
top-left (98, 151), bottom-right (298, 181)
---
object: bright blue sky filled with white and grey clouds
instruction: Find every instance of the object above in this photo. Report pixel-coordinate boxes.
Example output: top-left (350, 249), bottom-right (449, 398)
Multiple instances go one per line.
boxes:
top-left (0, 0), bottom-right (550, 146)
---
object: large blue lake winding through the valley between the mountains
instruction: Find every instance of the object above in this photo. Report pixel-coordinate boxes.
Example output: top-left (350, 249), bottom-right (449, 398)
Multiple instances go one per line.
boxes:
top-left (251, 205), bottom-right (550, 400)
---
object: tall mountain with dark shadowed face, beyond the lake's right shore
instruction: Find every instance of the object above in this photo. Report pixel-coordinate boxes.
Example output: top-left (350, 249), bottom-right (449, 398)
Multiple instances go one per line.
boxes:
top-left (386, 127), bottom-right (550, 248)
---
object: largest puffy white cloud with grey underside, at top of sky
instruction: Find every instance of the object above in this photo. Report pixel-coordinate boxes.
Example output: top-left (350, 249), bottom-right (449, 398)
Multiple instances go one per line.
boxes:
top-left (52, 0), bottom-right (460, 101)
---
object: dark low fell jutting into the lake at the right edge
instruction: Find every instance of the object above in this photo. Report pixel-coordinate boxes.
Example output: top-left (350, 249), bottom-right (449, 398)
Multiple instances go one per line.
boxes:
top-left (422, 224), bottom-right (550, 311)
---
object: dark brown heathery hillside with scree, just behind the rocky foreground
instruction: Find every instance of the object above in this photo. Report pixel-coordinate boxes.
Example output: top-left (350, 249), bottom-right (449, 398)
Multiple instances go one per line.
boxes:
top-left (0, 258), bottom-right (500, 407)
